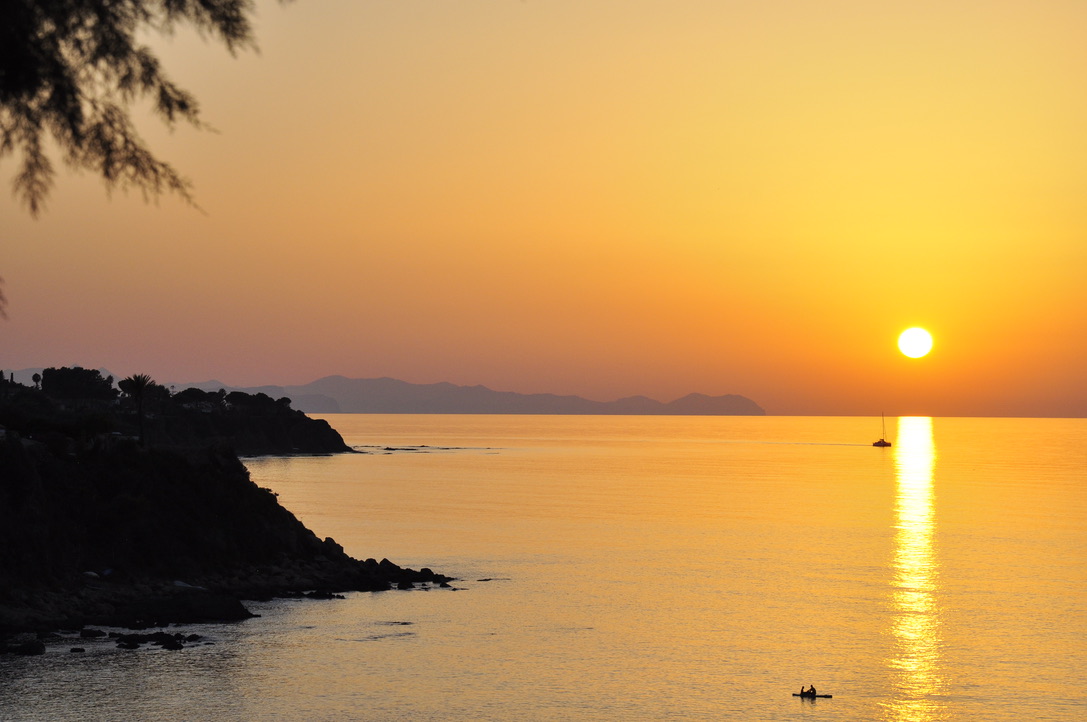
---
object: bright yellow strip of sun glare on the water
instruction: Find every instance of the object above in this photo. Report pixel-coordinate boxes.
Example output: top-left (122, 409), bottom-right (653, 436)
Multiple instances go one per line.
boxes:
top-left (888, 416), bottom-right (944, 722)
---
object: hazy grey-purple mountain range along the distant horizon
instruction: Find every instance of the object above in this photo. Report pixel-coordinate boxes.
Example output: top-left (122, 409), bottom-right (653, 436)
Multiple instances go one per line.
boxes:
top-left (177, 376), bottom-right (766, 415)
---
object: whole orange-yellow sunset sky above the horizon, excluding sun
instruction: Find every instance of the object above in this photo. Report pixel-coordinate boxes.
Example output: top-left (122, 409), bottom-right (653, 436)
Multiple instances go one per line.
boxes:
top-left (0, 0), bottom-right (1087, 416)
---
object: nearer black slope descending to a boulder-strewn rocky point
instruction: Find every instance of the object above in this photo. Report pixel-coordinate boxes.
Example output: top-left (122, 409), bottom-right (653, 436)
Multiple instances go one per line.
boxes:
top-left (0, 378), bottom-right (452, 653)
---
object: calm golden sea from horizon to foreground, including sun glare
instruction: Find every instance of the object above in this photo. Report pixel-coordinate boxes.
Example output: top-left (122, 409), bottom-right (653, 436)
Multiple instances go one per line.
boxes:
top-left (0, 414), bottom-right (1087, 722)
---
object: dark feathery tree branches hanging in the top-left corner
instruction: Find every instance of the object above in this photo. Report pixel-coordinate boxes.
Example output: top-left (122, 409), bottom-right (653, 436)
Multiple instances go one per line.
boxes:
top-left (0, 0), bottom-right (280, 214)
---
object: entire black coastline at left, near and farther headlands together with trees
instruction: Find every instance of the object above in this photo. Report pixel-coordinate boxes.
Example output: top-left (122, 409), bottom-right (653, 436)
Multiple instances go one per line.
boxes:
top-left (0, 369), bottom-right (450, 651)
